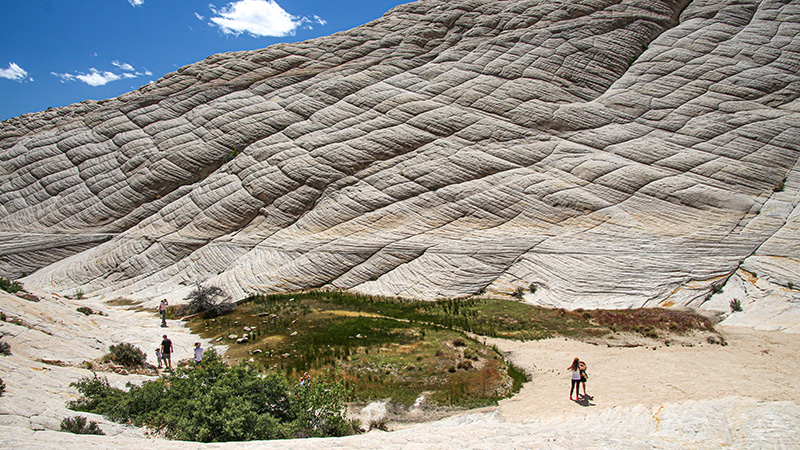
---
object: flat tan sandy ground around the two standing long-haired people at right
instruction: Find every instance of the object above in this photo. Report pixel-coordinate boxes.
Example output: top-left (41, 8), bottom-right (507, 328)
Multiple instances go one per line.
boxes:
top-left (488, 326), bottom-right (800, 422)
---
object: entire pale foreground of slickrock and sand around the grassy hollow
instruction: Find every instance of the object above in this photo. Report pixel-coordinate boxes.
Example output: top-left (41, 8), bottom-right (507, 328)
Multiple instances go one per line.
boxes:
top-left (0, 292), bottom-right (800, 450)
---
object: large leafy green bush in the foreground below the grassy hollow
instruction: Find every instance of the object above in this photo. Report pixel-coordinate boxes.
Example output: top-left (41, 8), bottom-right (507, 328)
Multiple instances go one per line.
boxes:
top-left (68, 349), bottom-right (352, 442)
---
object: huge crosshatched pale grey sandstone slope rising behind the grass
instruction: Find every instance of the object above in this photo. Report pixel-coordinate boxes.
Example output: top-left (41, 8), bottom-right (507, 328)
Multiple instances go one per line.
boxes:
top-left (0, 0), bottom-right (800, 328)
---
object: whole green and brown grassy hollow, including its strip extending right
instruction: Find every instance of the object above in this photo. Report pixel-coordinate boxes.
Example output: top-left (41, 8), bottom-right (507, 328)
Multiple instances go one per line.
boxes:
top-left (190, 291), bottom-right (713, 407)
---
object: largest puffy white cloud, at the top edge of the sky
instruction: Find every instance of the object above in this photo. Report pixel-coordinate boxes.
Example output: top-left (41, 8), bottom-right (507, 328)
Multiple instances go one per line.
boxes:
top-left (209, 0), bottom-right (309, 37)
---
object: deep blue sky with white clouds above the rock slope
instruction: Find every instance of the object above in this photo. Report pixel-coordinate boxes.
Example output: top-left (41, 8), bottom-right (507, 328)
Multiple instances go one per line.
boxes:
top-left (0, 0), bottom-right (411, 120)
